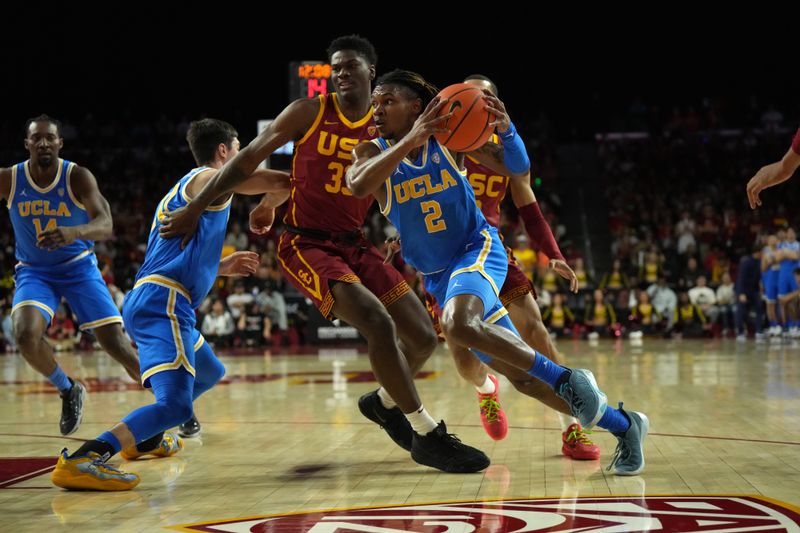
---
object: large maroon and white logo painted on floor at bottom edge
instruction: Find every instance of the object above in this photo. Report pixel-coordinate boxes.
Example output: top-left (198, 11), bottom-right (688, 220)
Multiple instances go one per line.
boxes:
top-left (174, 496), bottom-right (800, 533)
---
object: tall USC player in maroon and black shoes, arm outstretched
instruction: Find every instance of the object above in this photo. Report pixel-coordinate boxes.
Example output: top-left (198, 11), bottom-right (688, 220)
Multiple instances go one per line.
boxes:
top-left (153, 36), bottom-right (489, 472)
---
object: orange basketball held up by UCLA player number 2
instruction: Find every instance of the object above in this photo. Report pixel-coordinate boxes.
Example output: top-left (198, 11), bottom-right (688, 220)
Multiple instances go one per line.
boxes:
top-left (435, 83), bottom-right (494, 152)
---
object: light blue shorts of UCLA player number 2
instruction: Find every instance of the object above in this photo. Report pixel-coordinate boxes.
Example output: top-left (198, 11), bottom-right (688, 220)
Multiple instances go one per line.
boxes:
top-left (425, 225), bottom-right (508, 319)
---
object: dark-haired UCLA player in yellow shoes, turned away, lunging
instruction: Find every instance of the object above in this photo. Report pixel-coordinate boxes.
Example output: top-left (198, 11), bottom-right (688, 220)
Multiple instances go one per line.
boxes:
top-left (51, 119), bottom-right (289, 490)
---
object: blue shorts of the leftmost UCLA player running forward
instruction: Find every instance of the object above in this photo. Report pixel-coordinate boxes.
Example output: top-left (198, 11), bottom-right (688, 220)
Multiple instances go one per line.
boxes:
top-left (11, 252), bottom-right (122, 330)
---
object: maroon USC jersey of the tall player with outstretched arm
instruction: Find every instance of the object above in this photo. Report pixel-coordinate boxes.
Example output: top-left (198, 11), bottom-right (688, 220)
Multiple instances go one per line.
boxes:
top-left (283, 93), bottom-right (378, 232)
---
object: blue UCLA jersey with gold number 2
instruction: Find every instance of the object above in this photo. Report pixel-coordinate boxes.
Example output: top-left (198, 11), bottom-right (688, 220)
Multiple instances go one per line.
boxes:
top-left (372, 137), bottom-right (488, 274)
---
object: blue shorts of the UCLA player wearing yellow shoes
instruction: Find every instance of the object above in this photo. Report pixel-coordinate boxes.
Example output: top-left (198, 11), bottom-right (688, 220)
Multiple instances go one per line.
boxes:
top-left (122, 276), bottom-right (204, 387)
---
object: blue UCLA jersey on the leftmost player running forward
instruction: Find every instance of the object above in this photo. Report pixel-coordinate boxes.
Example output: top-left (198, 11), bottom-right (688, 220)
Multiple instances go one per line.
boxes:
top-left (8, 159), bottom-right (94, 266)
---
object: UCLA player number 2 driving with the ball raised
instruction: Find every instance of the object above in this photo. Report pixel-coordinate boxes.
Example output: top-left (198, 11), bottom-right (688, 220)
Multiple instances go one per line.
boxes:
top-left (347, 70), bottom-right (648, 475)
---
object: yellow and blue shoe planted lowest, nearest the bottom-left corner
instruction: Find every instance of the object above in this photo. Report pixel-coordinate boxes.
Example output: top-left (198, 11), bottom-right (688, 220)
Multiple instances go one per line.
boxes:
top-left (50, 448), bottom-right (141, 491)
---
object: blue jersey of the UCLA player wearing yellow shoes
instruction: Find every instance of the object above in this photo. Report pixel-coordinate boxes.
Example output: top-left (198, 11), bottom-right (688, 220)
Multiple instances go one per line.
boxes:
top-left (136, 167), bottom-right (231, 308)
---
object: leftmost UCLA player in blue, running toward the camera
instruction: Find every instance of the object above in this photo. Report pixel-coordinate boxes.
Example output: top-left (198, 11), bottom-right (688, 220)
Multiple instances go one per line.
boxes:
top-left (0, 115), bottom-right (139, 435)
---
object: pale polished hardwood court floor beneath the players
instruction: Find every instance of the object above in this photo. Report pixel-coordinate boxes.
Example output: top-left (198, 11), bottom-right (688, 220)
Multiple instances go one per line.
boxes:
top-left (0, 339), bottom-right (800, 532)
